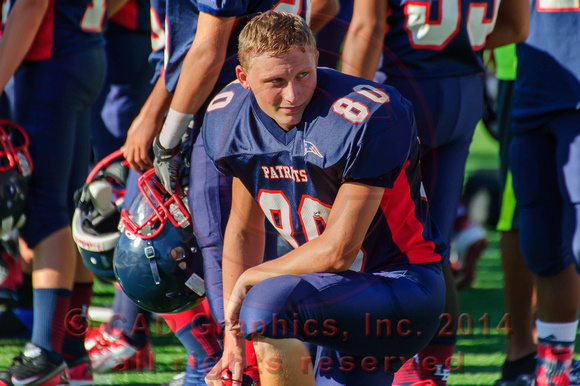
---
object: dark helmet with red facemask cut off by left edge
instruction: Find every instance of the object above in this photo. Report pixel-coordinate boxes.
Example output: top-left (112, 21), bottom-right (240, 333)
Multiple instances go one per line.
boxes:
top-left (0, 120), bottom-right (32, 236)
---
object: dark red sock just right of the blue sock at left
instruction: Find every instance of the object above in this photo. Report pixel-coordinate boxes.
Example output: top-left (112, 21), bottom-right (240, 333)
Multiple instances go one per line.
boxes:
top-left (62, 282), bottom-right (93, 361)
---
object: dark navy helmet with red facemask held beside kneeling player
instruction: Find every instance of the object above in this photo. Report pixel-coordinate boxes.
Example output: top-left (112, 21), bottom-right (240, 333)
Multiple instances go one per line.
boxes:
top-left (113, 169), bottom-right (205, 313)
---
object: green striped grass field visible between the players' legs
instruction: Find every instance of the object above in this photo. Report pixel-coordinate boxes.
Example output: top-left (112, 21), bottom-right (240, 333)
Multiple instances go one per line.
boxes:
top-left (0, 128), bottom-right (506, 386)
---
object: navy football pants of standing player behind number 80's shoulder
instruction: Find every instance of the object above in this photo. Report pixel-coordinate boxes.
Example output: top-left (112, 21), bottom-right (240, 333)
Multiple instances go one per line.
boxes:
top-left (385, 74), bottom-right (483, 261)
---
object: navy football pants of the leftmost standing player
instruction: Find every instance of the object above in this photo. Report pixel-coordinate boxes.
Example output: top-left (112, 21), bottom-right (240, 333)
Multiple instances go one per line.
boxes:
top-left (14, 47), bottom-right (105, 248)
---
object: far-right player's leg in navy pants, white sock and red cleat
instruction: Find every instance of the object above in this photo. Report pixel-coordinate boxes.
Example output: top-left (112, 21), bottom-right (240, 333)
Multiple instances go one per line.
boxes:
top-left (510, 117), bottom-right (580, 385)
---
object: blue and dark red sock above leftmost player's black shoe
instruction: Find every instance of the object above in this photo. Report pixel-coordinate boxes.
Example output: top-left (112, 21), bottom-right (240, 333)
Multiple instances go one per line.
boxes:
top-left (31, 288), bottom-right (71, 363)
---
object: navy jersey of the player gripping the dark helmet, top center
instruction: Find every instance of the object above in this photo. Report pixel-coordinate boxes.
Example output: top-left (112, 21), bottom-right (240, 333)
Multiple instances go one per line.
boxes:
top-left (165, 0), bottom-right (310, 94)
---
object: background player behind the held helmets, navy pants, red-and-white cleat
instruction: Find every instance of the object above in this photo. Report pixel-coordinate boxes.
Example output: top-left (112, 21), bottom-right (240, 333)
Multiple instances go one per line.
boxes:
top-left (86, 0), bottom-right (154, 372)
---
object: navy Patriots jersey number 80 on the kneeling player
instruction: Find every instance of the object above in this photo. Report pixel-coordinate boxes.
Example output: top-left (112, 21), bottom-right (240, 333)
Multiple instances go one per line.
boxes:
top-left (202, 69), bottom-right (446, 272)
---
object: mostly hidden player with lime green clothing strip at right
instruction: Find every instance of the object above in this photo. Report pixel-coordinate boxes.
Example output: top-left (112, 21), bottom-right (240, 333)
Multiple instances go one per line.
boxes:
top-left (493, 44), bottom-right (536, 386)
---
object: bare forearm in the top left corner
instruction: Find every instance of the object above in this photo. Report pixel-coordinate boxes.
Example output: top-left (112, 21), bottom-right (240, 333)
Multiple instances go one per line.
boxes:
top-left (0, 0), bottom-right (48, 90)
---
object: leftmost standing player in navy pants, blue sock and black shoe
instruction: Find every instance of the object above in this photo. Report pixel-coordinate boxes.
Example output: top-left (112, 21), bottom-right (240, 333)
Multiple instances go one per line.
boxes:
top-left (0, 0), bottom-right (121, 385)
